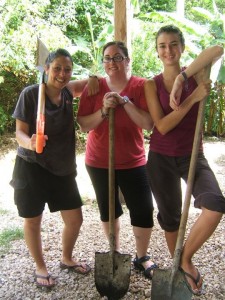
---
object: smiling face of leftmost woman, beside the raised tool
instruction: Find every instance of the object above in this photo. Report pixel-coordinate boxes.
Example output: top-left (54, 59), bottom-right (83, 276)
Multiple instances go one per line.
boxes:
top-left (45, 56), bottom-right (73, 90)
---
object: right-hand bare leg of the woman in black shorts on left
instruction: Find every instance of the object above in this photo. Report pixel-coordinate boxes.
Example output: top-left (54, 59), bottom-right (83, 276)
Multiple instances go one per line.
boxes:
top-left (61, 208), bottom-right (83, 266)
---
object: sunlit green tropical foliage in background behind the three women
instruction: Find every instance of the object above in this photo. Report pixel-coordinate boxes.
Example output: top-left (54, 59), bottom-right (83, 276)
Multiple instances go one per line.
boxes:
top-left (0, 0), bottom-right (225, 136)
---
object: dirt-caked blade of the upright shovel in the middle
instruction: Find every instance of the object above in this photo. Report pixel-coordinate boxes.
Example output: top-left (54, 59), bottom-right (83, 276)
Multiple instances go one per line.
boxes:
top-left (95, 251), bottom-right (131, 300)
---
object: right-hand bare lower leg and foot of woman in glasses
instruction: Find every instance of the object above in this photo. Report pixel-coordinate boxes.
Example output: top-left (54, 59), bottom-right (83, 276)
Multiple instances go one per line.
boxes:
top-left (133, 226), bottom-right (154, 269)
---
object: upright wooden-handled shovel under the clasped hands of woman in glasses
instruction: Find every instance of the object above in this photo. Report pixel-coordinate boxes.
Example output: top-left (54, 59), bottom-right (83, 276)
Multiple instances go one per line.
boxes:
top-left (95, 108), bottom-right (131, 300)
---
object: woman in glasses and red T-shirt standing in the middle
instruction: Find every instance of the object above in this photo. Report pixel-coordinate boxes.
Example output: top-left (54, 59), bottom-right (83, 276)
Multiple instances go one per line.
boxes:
top-left (77, 42), bottom-right (156, 279)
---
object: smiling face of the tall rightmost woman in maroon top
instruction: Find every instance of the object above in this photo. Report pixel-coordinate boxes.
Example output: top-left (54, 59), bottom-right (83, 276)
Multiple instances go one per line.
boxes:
top-left (156, 32), bottom-right (184, 65)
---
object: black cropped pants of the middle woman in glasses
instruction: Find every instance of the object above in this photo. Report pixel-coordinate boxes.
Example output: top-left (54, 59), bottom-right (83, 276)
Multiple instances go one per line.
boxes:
top-left (86, 165), bottom-right (154, 228)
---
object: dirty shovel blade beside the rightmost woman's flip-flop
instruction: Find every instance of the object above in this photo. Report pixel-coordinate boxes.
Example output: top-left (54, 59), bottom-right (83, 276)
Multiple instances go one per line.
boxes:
top-left (151, 269), bottom-right (192, 300)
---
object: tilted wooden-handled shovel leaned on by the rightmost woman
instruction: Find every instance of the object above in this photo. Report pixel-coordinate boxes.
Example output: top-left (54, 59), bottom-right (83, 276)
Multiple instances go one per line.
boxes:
top-left (151, 65), bottom-right (211, 300)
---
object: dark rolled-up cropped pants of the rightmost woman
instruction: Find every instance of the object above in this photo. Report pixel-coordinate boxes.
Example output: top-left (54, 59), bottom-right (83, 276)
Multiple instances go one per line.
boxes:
top-left (147, 151), bottom-right (225, 232)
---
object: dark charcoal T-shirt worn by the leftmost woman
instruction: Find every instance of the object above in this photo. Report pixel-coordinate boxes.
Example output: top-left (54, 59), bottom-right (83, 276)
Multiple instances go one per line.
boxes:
top-left (13, 84), bottom-right (76, 176)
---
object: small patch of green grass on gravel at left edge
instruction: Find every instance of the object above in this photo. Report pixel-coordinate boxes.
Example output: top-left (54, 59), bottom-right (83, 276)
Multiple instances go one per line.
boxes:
top-left (0, 227), bottom-right (24, 253)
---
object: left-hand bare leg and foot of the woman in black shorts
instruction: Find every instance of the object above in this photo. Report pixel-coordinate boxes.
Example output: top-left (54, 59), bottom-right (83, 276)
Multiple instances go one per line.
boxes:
top-left (24, 215), bottom-right (54, 285)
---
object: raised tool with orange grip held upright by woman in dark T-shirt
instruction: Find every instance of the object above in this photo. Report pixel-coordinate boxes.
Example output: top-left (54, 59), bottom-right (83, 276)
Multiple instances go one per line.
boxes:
top-left (36, 38), bottom-right (49, 153)
